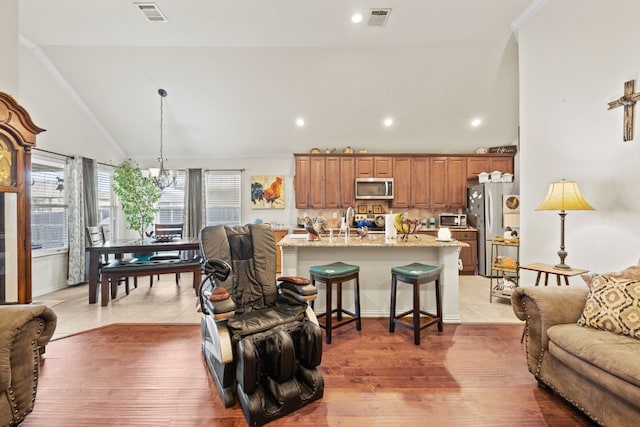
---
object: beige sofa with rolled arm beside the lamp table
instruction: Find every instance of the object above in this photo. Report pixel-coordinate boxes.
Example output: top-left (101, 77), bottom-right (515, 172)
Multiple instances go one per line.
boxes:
top-left (511, 287), bottom-right (640, 426)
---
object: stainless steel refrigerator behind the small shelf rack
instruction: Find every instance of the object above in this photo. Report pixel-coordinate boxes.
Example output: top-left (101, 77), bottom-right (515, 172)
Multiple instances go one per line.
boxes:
top-left (467, 182), bottom-right (517, 276)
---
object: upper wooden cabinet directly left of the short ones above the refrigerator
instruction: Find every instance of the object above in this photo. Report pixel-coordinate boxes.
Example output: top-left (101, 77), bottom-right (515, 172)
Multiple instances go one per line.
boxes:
top-left (429, 157), bottom-right (467, 209)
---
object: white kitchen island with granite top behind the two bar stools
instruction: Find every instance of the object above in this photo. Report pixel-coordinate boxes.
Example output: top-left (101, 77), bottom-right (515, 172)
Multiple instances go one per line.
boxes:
top-left (278, 234), bottom-right (469, 323)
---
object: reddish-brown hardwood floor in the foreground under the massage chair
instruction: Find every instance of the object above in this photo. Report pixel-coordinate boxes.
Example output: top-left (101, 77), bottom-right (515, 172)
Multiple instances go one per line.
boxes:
top-left (22, 318), bottom-right (592, 427)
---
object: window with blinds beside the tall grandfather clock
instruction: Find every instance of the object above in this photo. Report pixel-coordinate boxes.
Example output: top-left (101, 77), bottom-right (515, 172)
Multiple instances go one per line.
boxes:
top-left (31, 156), bottom-right (69, 249)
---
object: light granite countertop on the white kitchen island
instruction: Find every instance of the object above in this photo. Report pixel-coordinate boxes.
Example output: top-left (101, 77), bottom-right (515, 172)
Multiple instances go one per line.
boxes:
top-left (277, 234), bottom-right (469, 248)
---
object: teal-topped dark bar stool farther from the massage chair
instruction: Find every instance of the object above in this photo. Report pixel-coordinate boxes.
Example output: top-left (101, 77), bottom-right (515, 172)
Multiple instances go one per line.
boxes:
top-left (389, 262), bottom-right (442, 345)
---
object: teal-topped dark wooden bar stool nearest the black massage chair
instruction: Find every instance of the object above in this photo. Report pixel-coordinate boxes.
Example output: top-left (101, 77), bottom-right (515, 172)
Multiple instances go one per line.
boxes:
top-left (309, 262), bottom-right (361, 344)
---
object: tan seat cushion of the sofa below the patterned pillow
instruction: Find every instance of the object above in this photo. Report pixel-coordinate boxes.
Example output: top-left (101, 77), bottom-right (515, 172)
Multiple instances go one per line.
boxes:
top-left (547, 324), bottom-right (640, 392)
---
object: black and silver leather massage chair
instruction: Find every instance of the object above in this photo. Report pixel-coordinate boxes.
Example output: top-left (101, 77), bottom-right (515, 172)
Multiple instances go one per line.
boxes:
top-left (199, 224), bottom-right (324, 425)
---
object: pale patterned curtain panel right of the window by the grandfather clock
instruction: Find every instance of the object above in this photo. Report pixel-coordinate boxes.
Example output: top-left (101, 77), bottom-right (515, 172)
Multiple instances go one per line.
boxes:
top-left (65, 157), bottom-right (86, 285)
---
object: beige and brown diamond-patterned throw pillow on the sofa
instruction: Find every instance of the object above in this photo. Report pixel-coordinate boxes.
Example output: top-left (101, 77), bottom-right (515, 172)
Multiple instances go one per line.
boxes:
top-left (578, 275), bottom-right (640, 339)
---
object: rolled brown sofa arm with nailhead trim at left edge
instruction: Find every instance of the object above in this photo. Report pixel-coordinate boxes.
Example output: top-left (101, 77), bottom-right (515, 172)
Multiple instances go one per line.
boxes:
top-left (0, 305), bottom-right (57, 426)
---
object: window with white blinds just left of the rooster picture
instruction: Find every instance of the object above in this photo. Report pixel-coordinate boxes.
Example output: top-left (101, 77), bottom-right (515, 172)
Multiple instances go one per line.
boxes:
top-left (205, 170), bottom-right (241, 225)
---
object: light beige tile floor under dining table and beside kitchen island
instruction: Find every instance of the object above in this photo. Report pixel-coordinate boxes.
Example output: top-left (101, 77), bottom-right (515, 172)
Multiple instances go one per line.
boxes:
top-left (33, 274), bottom-right (520, 339)
